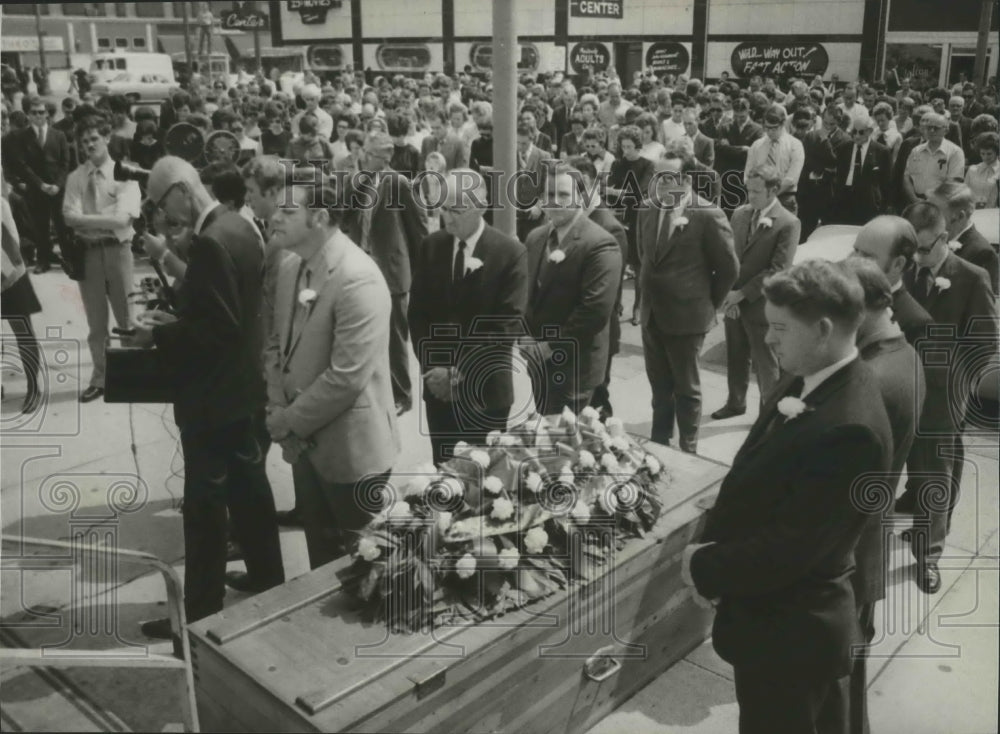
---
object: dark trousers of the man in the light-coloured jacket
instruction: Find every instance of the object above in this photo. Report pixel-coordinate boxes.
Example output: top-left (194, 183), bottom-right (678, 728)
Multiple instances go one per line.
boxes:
top-left (292, 456), bottom-right (389, 569)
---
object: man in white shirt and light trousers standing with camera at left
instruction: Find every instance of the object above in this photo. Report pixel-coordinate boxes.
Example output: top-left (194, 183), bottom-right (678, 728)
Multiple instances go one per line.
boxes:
top-left (62, 116), bottom-right (142, 403)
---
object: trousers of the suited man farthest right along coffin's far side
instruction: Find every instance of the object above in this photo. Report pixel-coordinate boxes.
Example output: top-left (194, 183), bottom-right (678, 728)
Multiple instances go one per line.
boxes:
top-left (724, 310), bottom-right (781, 410)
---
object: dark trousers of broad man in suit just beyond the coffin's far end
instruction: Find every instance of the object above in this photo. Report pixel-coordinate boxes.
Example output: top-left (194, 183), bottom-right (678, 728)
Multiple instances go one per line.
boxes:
top-left (642, 315), bottom-right (705, 454)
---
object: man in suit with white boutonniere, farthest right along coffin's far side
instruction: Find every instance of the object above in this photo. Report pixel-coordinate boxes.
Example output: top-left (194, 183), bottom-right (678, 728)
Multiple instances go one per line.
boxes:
top-left (712, 165), bottom-right (800, 420)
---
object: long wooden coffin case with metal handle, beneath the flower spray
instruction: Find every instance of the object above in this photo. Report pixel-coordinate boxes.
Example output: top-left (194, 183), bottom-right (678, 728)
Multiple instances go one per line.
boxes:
top-left (190, 443), bottom-right (726, 734)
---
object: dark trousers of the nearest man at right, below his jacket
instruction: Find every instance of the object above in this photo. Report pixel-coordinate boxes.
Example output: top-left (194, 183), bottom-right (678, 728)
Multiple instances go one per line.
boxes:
top-left (733, 667), bottom-right (847, 734)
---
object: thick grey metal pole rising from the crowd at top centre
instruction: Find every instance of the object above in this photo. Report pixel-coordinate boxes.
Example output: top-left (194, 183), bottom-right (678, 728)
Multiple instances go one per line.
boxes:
top-left (493, 0), bottom-right (518, 237)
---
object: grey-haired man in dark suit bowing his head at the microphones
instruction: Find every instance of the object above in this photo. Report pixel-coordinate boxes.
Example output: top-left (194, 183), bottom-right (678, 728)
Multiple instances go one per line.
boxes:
top-left (135, 156), bottom-right (285, 638)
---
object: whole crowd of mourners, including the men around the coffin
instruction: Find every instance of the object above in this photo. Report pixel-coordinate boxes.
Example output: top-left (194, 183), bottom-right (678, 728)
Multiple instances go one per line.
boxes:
top-left (3, 60), bottom-right (1000, 734)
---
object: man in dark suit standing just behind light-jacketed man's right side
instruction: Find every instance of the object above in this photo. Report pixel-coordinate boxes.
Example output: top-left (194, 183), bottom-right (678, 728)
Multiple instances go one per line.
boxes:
top-left (346, 132), bottom-right (427, 415)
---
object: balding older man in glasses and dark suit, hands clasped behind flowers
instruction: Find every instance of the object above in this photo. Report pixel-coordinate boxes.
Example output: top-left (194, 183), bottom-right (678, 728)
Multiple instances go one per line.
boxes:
top-left (409, 168), bottom-right (528, 464)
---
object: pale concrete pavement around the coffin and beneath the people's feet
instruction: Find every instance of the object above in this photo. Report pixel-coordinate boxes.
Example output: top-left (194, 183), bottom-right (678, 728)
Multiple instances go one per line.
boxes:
top-left (0, 268), bottom-right (1000, 734)
